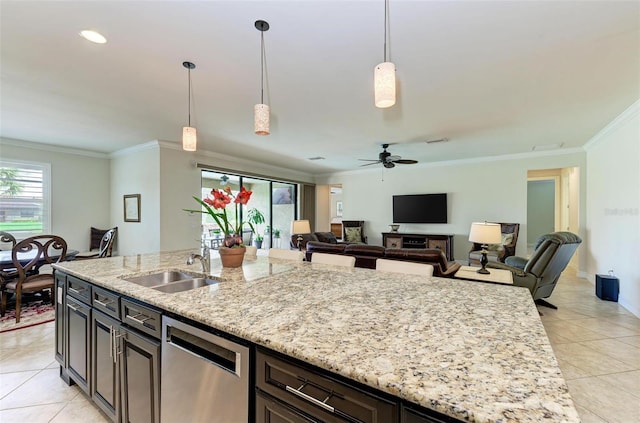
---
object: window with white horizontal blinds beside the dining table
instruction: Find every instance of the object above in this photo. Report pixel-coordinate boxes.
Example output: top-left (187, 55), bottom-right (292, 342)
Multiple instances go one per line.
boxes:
top-left (0, 160), bottom-right (51, 240)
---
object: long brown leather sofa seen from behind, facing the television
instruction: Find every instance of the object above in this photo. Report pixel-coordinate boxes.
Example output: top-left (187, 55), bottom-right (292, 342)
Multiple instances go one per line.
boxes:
top-left (306, 241), bottom-right (460, 277)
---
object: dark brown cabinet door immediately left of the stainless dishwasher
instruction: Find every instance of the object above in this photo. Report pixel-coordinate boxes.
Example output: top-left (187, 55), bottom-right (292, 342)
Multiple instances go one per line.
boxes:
top-left (116, 326), bottom-right (160, 423)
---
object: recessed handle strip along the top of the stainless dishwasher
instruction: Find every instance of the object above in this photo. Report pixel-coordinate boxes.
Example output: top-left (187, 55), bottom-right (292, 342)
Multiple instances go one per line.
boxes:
top-left (165, 325), bottom-right (242, 377)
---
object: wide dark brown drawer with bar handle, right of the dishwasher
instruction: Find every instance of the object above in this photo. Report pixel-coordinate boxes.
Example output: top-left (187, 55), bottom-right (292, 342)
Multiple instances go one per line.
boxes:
top-left (256, 350), bottom-right (398, 423)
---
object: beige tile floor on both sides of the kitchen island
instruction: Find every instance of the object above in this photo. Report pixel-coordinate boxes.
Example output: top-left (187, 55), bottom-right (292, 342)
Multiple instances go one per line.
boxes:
top-left (0, 269), bottom-right (640, 423)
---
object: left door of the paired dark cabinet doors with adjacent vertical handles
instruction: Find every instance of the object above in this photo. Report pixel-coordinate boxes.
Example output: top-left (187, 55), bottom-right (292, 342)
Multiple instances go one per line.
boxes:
top-left (91, 310), bottom-right (120, 421)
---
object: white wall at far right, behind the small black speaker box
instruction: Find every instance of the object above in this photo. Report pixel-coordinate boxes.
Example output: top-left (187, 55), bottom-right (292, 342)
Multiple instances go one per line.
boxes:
top-left (586, 102), bottom-right (640, 316)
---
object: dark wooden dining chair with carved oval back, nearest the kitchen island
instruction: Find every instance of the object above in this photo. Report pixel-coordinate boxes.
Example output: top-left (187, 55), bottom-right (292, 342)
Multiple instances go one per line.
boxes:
top-left (0, 235), bottom-right (67, 323)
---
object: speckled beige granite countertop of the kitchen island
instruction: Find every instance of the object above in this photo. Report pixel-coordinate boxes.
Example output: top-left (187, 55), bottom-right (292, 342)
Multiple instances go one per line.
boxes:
top-left (54, 250), bottom-right (580, 423)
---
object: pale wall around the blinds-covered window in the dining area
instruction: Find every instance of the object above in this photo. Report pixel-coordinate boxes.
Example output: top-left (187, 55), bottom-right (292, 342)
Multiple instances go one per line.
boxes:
top-left (0, 139), bottom-right (109, 251)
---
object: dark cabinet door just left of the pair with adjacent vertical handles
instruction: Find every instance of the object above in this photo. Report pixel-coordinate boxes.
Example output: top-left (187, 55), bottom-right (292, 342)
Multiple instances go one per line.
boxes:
top-left (65, 295), bottom-right (91, 394)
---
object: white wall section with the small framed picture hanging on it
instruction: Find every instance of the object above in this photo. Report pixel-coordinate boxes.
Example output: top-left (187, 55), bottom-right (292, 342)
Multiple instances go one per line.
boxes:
top-left (111, 143), bottom-right (161, 256)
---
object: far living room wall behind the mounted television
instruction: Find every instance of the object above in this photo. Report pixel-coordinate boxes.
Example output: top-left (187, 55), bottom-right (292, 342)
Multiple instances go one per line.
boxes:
top-left (318, 151), bottom-right (586, 263)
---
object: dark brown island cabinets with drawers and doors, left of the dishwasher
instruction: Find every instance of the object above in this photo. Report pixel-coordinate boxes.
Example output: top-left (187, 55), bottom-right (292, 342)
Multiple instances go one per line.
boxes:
top-left (56, 272), bottom-right (161, 423)
